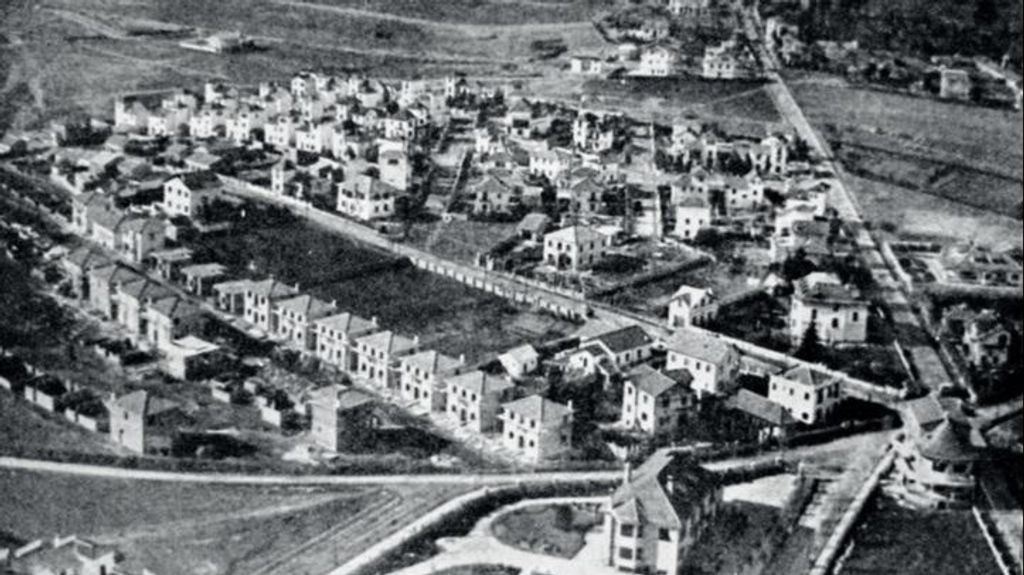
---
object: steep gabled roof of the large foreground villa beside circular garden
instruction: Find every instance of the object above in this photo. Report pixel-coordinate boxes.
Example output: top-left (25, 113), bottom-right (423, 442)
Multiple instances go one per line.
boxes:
top-left (611, 449), bottom-right (719, 529)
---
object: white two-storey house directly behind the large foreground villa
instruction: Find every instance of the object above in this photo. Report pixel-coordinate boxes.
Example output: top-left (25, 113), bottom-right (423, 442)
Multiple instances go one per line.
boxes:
top-left (622, 364), bottom-right (696, 435)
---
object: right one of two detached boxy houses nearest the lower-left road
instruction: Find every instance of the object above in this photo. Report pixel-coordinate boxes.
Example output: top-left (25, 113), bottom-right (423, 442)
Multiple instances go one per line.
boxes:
top-left (309, 386), bottom-right (381, 451)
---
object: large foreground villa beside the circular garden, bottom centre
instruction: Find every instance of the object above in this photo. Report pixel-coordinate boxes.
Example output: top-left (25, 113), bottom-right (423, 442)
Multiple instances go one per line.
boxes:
top-left (603, 450), bottom-right (722, 575)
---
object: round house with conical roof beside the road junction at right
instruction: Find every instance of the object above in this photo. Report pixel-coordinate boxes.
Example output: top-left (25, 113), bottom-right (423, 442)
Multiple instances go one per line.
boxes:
top-left (895, 396), bottom-right (985, 507)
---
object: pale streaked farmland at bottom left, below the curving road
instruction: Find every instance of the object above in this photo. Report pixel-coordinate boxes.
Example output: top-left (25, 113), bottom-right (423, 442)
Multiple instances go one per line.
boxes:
top-left (0, 472), bottom-right (471, 575)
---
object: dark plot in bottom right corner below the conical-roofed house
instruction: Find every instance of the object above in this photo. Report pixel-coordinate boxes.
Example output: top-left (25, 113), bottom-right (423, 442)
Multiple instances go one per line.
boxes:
top-left (837, 487), bottom-right (999, 575)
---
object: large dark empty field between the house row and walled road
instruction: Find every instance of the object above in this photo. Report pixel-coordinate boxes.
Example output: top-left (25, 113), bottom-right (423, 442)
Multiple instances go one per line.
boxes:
top-left (192, 214), bottom-right (572, 361)
